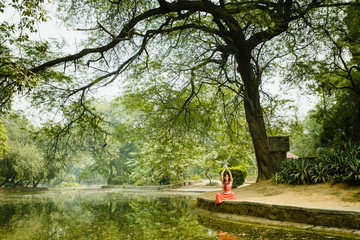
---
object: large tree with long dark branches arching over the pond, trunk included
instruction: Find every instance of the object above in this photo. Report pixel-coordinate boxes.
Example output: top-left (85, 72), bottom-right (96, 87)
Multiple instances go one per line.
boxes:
top-left (2, 0), bottom-right (350, 180)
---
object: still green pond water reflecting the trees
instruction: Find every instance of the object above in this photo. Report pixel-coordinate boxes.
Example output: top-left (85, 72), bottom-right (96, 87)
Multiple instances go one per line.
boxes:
top-left (0, 189), bottom-right (351, 240)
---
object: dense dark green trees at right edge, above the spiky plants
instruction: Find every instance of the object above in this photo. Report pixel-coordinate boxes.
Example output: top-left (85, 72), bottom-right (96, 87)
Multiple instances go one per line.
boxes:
top-left (289, 5), bottom-right (360, 150)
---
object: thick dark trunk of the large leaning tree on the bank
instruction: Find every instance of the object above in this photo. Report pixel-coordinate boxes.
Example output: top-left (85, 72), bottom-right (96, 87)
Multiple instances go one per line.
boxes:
top-left (237, 57), bottom-right (276, 182)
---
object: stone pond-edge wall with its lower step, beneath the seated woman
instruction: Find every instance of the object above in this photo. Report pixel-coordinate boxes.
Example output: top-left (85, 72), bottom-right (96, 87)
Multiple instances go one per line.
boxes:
top-left (197, 197), bottom-right (360, 234)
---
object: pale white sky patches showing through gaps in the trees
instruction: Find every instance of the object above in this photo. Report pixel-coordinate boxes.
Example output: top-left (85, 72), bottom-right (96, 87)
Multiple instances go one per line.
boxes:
top-left (0, 4), bottom-right (318, 122)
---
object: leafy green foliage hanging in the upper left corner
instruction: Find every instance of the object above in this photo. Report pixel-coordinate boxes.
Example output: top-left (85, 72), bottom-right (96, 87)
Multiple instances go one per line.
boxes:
top-left (0, 0), bottom-right (48, 112)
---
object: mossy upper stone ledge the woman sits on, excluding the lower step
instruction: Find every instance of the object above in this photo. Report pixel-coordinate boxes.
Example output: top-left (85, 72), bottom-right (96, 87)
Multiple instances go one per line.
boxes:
top-left (197, 197), bottom-right (360, 229)
